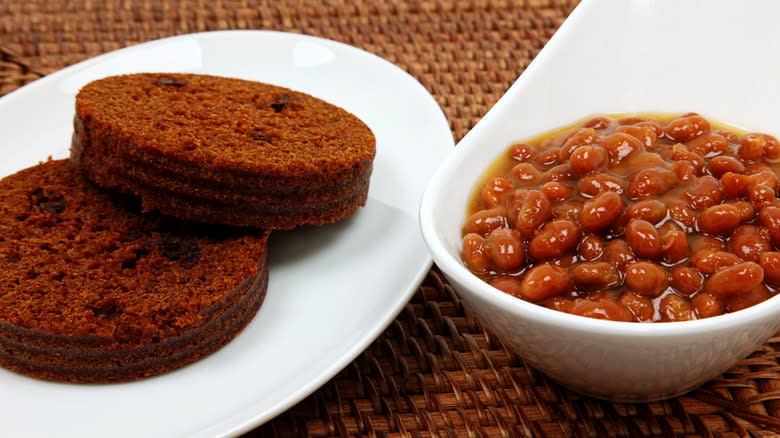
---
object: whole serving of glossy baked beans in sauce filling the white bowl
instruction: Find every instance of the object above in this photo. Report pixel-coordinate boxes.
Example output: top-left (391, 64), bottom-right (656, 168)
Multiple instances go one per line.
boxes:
top-left (461, 113), bottom-right (780, 322)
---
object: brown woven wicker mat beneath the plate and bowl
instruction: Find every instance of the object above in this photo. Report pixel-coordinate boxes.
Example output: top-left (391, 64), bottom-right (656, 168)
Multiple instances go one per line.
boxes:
top-left (0, 0), bottom-right (780, 438)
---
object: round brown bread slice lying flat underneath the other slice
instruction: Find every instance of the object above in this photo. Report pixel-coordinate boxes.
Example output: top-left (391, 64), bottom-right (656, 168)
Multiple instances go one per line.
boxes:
top-left (0, 160), bottom-right (269, 382)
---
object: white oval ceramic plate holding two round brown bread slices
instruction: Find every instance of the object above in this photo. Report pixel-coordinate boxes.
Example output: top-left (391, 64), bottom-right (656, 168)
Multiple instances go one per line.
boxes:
top-left (0, 31), bottom-right (454, 437)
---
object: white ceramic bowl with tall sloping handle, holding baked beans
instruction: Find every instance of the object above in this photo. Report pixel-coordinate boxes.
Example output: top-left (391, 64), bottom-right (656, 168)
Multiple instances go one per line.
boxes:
top-left (420, 0), bottom-right (780, 401)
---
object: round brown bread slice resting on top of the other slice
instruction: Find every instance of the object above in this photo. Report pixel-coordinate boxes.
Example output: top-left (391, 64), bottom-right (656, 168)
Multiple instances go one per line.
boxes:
top-left (71, 73), bottom-right (376, 229)
